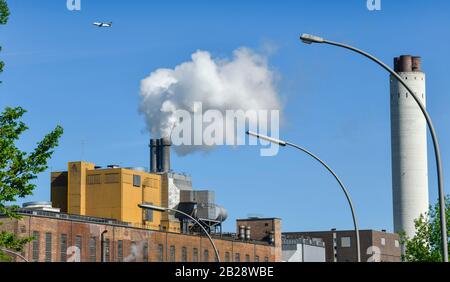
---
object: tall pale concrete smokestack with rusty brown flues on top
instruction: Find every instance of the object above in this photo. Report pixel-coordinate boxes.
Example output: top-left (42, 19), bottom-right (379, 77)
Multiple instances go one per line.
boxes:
top-left (390, 55), bottom-right (429, 240)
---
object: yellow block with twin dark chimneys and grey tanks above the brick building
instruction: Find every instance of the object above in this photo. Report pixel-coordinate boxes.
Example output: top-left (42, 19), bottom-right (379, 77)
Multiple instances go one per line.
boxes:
top-left (51, 138), bottom-right (228, 233)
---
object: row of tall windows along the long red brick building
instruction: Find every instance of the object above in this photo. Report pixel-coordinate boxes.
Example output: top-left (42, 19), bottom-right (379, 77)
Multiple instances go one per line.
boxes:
top-left (32, 231), bottom-right (269, 262)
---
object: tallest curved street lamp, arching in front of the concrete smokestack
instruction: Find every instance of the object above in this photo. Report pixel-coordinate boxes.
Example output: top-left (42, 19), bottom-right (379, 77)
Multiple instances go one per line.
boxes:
top-left (300, 34), bottom-right (448, 262)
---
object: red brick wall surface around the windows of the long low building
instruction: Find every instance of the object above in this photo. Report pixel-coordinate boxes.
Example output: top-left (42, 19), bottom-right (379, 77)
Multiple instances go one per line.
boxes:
top-left (0, 216), bottom-right (281, 262)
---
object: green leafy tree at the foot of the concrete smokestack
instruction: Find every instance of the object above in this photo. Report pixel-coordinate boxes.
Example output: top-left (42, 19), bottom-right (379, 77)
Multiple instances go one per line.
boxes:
top-left (401, 196), bottom-right (450, 262)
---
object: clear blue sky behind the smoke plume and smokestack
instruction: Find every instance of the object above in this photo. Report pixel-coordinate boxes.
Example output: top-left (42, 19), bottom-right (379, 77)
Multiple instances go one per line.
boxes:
top-left (0, 0), bottom-right (450, 231)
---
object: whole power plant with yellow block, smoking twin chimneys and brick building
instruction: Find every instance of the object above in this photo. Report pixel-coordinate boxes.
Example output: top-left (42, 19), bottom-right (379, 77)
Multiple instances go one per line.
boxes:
top-left (0, 139), bottom-right (281, 262)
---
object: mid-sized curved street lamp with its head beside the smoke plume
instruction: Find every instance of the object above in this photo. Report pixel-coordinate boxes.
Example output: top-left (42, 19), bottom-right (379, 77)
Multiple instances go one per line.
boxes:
top-left (247, 131), bottom-right (361, 262)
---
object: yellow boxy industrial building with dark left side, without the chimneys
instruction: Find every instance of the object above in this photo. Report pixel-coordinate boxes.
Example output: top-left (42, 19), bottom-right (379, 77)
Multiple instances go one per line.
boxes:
top-left (51, 161), bottom-right (180, 232)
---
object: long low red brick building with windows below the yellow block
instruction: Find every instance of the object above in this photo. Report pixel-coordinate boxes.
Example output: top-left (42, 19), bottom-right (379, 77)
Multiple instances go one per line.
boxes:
top-left (0, 211), bottom-right (281, 262)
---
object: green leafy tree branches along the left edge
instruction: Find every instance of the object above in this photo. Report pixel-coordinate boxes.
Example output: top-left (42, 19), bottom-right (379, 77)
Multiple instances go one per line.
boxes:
top-left (0, 0), bottom-right (63, 261)
